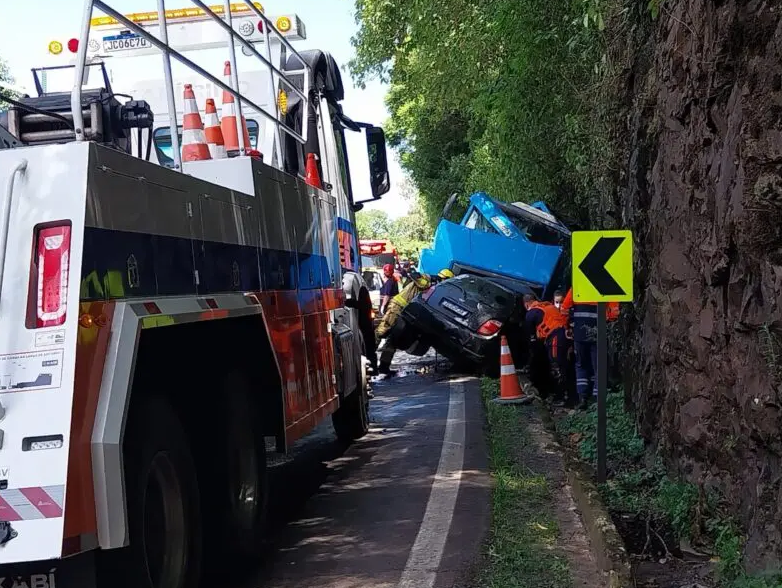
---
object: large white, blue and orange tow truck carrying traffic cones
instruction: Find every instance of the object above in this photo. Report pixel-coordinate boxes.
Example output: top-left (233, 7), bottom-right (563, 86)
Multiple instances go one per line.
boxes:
top-left (0, 0), bottom-right (389, 588)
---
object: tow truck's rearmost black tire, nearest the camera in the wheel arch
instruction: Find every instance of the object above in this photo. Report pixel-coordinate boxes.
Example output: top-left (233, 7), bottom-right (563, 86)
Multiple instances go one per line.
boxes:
top-left (98, 397), bottom-right (203, 588)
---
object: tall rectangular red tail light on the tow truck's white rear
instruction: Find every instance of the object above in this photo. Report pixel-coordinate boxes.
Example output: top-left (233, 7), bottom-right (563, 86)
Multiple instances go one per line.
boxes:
top-left (29, 223), bottom-right (71, 329)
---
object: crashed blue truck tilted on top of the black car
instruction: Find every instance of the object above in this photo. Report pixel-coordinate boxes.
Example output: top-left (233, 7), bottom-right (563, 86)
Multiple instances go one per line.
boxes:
top-left (419, 192), bottom-right (570, 298)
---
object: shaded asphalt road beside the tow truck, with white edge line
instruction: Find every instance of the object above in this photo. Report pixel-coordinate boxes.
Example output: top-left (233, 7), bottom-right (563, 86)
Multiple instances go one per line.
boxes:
top-left (242, 356), bottom-right (490, 588)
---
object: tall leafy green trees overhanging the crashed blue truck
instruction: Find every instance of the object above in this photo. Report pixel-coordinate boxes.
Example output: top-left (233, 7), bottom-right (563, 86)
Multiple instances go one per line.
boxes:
top-left (350, 0), bottom-right (620, 227)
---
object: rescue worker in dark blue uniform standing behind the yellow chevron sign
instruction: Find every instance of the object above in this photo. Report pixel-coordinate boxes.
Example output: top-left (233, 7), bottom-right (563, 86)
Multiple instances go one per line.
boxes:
top-left (561, 288), bottom-right (619, 410)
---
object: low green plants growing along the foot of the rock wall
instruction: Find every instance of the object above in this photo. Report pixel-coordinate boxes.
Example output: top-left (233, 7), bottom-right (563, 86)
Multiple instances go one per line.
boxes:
top-left (557, 391), bottom-right (782, 588)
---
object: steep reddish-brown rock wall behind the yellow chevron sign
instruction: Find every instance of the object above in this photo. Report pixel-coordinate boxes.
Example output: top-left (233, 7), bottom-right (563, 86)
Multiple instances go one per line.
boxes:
top-left (621, 0), bottom-right (782, 567)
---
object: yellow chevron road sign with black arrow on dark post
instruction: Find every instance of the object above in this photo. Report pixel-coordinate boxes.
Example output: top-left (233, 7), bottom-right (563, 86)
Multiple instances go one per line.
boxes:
top-left (572, 231), bottom-right (633, 484)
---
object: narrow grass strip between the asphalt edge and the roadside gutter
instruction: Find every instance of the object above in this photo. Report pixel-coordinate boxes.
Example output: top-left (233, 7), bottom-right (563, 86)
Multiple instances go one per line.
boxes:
top-left (478, 378), bottom-right (571, 588)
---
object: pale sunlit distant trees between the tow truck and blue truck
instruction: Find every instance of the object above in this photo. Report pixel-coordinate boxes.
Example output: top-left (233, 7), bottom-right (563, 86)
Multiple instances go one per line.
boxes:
top-left (356, 186), bottom-right (433, 259)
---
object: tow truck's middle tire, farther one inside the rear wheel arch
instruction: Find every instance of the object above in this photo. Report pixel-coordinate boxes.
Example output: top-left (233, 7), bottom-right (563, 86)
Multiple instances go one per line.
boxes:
top-left (208, 372), bottom-right (269, 561)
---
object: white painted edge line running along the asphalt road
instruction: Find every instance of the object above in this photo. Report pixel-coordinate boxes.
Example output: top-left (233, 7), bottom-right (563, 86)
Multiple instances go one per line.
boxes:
top-left (399, 381), bottom-right (466, 588)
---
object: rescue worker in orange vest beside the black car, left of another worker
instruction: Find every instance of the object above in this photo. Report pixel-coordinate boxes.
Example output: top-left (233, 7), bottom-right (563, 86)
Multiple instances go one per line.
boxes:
top-left (524, 294), bottom-right (570, 405)
